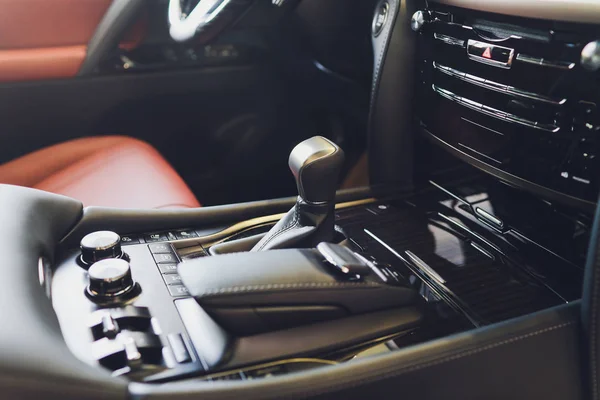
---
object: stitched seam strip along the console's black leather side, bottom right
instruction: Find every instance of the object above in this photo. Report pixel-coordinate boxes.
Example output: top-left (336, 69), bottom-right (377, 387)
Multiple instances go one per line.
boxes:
top-left (298, 321), bottom-right (577, 398)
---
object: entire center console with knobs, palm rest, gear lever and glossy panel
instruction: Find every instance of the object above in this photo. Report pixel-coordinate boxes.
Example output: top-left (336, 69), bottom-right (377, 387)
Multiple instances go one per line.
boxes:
top-left (41, 133), bottom-right (589, 384)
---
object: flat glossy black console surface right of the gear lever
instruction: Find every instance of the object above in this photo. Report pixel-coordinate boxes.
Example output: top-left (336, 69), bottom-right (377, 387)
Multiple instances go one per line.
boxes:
top-left (339, 185), bottom-right (586, 326)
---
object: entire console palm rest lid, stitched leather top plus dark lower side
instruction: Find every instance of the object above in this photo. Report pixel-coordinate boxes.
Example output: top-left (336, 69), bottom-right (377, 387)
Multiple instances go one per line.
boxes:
top-left (178, 249), bottom-right (417, 333)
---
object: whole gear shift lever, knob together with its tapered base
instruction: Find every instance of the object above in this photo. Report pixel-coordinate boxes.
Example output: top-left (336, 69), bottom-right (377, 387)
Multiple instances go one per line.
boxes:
top-left (252, 136), bottom-right (344, 251)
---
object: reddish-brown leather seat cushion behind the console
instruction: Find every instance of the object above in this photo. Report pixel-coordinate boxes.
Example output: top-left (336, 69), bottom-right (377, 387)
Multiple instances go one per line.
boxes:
top-left (0, 136), bottom-right (200, 208)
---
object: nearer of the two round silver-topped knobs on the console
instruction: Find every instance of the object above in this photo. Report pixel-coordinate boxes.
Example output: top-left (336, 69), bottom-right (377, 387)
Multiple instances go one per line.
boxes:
top-left (87, 258), bottom-right (139, 301)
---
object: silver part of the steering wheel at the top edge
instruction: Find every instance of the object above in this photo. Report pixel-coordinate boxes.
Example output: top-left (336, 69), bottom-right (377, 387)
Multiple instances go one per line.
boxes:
top-left (169, 0), bottom-right (252, 42)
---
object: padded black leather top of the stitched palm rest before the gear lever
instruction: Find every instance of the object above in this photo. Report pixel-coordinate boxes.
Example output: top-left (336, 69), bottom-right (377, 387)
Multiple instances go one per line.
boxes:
top-left (178, 249), bottom-right (417, 314)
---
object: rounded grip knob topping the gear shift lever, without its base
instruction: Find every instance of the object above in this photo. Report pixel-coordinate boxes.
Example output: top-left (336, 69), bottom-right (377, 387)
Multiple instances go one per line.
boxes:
top-left (289, 136), bottom-right (344, 204)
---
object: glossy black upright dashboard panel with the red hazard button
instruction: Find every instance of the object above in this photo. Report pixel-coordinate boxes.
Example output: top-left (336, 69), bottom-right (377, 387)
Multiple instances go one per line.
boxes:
top-left (416, 3), bottom-right (600, 210)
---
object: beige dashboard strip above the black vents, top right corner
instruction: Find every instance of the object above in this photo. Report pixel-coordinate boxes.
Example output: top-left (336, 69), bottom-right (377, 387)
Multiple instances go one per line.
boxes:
top-left (429, 0), bottom-right (600, 24)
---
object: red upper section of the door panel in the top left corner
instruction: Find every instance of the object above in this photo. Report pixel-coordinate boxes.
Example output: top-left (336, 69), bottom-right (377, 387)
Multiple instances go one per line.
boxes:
top-left (0, 0), bottom-right (144, 82)
